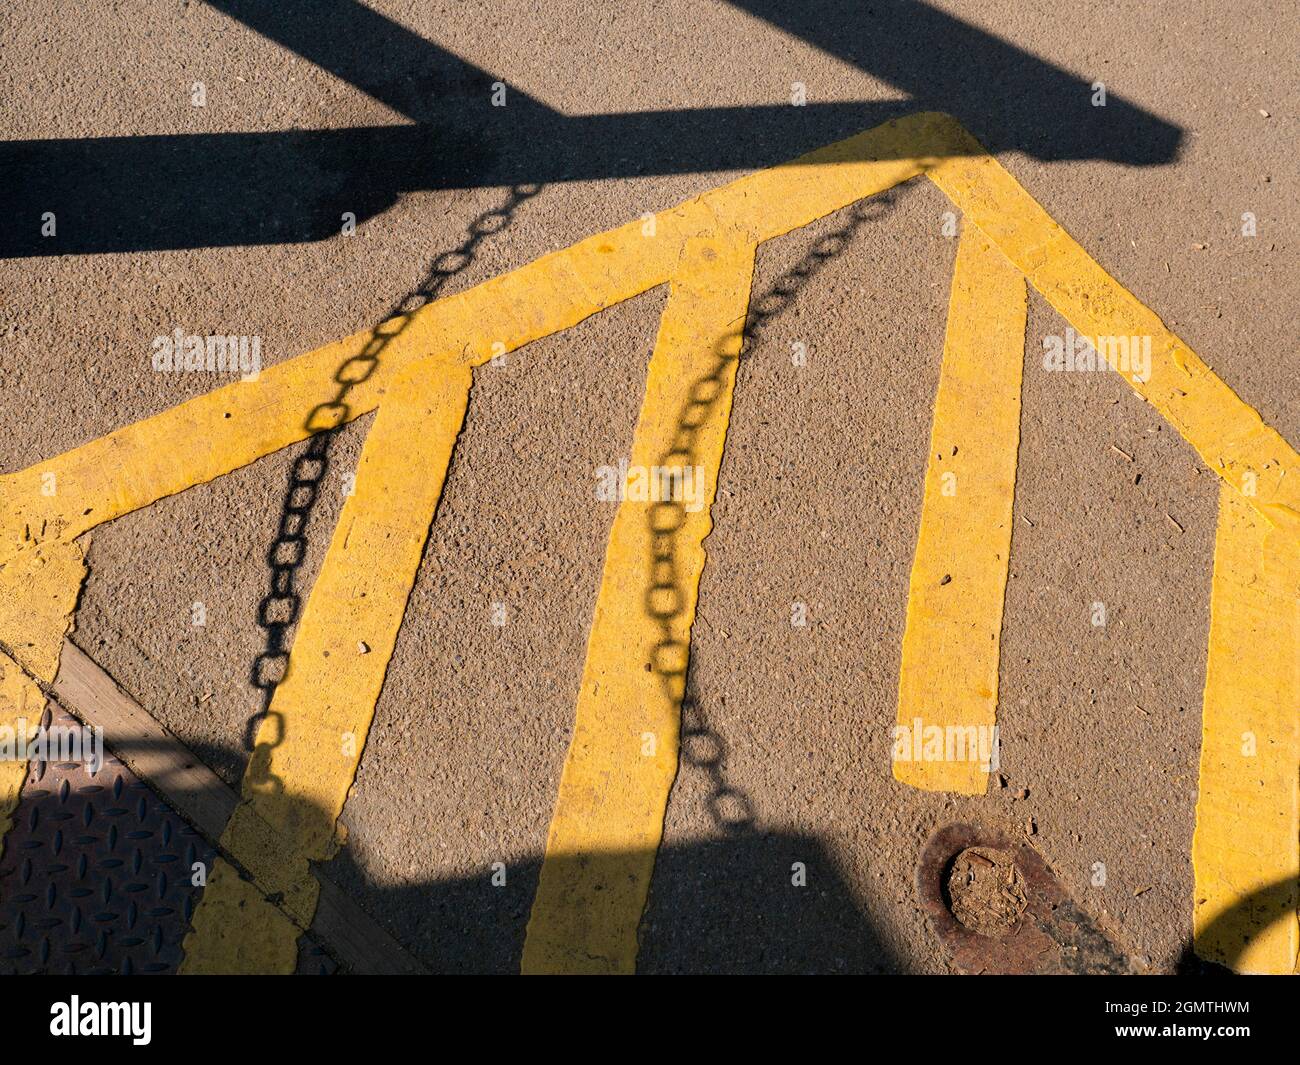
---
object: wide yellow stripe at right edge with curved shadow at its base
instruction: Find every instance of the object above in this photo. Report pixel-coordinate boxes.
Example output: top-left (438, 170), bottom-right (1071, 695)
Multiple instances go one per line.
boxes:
top-left (1192, 485), bottom-right (1300, 974)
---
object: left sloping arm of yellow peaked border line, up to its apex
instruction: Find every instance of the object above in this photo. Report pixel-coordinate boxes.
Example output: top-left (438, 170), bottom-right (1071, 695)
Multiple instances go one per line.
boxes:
top-left (0, 113), bottom-right (950, 560)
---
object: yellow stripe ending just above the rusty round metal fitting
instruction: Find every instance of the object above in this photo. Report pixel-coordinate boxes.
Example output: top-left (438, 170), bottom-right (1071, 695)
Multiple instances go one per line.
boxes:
top-left (893, 229), bottom-right (1027, 795)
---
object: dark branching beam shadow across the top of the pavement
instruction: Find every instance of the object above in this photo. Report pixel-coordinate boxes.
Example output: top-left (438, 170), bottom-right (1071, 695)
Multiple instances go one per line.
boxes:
top-left (0, 0), bottom-right (1182, 257)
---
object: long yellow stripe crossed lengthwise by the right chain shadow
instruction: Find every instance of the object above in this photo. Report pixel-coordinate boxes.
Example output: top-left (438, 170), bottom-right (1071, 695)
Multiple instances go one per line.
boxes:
top-left (523, 234), bottom-right (754, 973)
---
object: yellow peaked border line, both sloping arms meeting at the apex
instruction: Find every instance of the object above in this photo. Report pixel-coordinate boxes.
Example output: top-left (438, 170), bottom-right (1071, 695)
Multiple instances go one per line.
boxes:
top-left (0, 113), bottom-right (1300, 966)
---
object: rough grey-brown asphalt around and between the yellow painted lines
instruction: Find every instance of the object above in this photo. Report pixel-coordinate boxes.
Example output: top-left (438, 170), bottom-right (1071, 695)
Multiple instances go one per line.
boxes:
top-left (0, 0), bottom-right (1300, 971)
